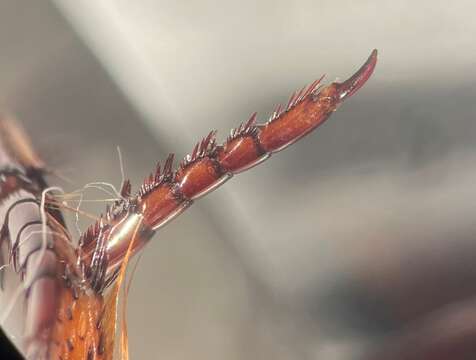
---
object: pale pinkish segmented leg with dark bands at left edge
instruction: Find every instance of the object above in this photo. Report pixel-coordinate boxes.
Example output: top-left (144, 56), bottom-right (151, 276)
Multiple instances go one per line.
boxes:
top-left (0, 119), bottom-right (62, 359)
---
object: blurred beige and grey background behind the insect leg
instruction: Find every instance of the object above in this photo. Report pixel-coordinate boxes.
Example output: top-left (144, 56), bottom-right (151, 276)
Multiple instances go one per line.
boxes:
top-left (0, 0), bottom-right (476, 360)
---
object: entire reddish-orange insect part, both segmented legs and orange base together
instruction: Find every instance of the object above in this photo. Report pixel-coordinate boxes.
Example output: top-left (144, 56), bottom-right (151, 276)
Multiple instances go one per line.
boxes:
top-left (0, 50), bottom-right (377, 360)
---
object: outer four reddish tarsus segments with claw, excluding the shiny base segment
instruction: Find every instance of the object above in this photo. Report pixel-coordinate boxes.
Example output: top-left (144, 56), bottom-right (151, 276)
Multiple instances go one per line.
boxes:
top-left (139, 50), bottom-right (377, 224)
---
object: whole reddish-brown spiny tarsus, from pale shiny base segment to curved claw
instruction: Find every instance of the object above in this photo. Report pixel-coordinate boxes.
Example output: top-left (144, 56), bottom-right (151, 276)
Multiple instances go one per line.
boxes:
top-left (80, 50), bottom-right (377, 286)
